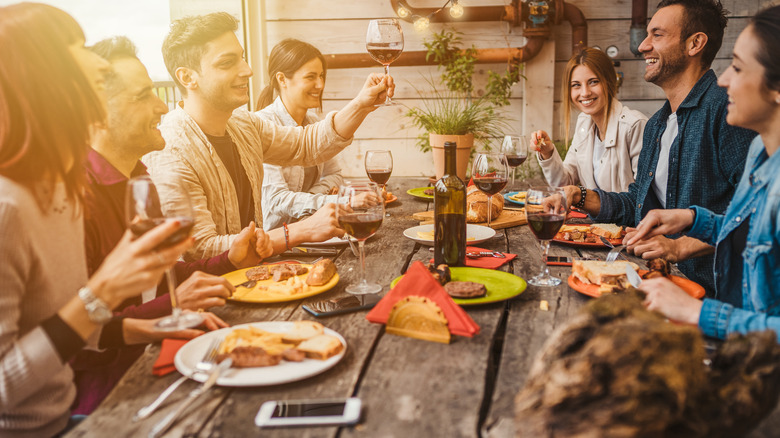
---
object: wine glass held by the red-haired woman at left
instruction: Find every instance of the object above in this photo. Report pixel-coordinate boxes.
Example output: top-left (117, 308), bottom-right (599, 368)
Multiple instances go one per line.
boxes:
top-left (125, 175), bottom-right (203, 331)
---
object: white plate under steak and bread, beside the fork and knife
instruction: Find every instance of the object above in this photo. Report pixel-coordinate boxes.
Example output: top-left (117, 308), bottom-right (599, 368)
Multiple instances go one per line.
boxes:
top-left (173, 321), bottom-right (347, 386)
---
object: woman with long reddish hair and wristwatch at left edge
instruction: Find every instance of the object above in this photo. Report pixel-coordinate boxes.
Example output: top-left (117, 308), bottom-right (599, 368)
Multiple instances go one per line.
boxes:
top-left (0, 3), bottom-right (192, 437)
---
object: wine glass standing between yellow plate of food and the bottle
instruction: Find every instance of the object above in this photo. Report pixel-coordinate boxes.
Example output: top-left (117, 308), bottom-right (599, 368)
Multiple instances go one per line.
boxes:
top-left (336, 182), bottom-right (385, 295)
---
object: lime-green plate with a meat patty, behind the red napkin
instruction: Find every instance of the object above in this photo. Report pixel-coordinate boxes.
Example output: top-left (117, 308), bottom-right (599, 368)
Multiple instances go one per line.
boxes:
top-left (390, 268), bottom-right (526, 306)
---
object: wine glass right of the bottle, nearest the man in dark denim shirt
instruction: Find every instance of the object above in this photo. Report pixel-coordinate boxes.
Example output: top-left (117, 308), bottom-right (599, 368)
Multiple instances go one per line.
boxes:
top-left (525, 186), bottom-right (568, 286)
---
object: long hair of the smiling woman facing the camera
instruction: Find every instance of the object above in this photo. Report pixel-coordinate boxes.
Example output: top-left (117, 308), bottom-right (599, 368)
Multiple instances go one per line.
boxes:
top-left (561, 47), bottom-right (617, 144)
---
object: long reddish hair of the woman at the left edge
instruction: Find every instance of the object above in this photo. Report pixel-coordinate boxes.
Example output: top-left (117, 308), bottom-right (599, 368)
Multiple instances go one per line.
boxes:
top-left (0, 3), bottom-right (105, 208)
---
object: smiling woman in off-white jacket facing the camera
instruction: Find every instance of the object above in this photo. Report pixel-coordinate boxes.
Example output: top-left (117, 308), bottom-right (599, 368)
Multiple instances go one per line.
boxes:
top-left (531, 48), bottom-right (647, 192)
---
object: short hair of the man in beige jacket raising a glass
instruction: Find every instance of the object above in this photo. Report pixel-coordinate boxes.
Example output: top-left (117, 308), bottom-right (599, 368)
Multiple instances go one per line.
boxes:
top-left (162, 12), bottom-right (238, 96)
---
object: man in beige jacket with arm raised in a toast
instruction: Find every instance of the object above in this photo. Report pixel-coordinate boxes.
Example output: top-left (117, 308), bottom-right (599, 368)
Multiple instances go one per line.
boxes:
top-left (143, 12), bottom-right (394, 260)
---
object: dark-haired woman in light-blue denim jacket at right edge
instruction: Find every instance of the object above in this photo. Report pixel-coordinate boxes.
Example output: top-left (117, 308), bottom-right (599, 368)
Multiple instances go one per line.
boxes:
top-left (626, 6), bottom-right (780, 339)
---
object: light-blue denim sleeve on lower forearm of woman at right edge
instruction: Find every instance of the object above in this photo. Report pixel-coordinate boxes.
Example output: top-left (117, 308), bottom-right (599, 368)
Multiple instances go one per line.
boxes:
top-left (699, 298), bottom-right (780, 342)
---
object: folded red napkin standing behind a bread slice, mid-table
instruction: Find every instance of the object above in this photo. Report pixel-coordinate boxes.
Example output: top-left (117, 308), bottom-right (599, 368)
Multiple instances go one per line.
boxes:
top-left (366, 261), bottom-right (479, 337)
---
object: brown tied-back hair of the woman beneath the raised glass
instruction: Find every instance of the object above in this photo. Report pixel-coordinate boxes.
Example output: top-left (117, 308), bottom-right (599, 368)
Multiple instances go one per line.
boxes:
top-left (255, 38), bottom-right (328, 110)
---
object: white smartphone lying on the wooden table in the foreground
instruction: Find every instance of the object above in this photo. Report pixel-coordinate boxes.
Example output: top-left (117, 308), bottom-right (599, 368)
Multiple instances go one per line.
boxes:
top-left (255, 397), bottom-right (361, 427)
